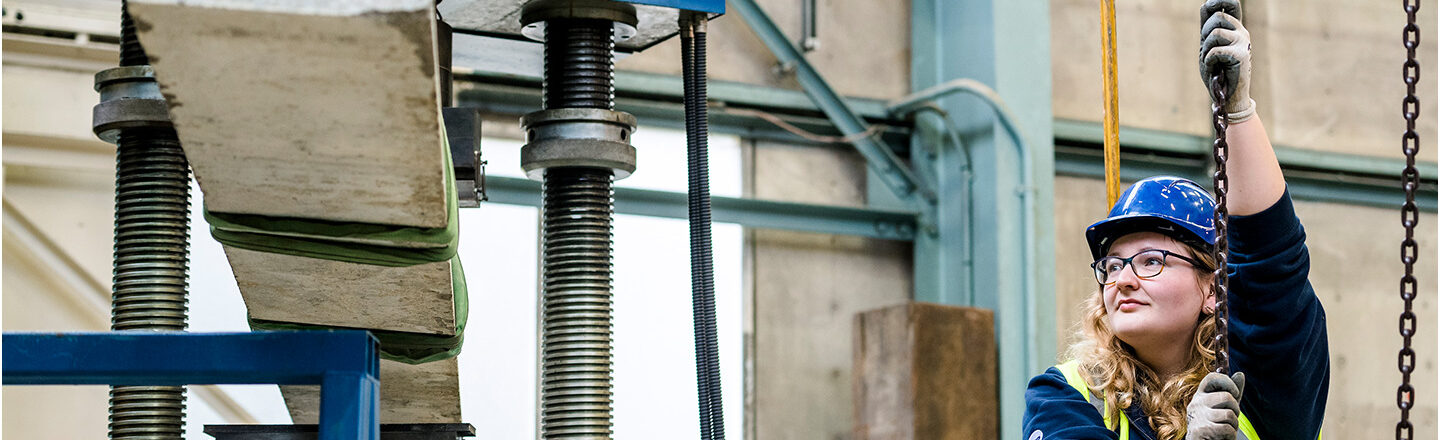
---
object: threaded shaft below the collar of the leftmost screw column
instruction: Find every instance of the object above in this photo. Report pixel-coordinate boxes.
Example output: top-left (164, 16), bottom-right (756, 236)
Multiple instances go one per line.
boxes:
top-left (109, 129), bottom-right (190, 440)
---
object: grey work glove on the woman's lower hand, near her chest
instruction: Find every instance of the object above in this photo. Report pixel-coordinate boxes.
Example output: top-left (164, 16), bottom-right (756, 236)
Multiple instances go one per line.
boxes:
top-left (1185, 372), bottom-right (1246, 440)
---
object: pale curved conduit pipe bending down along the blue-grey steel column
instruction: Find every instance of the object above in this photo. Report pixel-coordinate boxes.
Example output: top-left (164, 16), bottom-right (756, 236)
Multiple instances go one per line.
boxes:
top-left (886, 78), bottom-right (1037, 346)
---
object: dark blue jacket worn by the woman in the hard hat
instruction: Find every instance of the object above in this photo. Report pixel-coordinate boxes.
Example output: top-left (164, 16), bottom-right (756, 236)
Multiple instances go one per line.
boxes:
top-left (1022, 191), bottom-right (1331, 440)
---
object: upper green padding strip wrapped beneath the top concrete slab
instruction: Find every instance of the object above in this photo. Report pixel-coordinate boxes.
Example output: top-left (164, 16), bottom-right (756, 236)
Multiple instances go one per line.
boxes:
top-left (202, 131), bottom-right (459, 267)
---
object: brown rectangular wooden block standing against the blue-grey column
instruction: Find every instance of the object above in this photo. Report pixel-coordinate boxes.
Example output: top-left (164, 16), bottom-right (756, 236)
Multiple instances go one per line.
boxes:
top-left (854, 303), bottom-right (999, 440)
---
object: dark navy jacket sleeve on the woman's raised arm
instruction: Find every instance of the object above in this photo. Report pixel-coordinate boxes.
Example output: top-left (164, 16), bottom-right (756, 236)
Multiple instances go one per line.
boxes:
top-left (1227, 191), bottom-right (1331, 440)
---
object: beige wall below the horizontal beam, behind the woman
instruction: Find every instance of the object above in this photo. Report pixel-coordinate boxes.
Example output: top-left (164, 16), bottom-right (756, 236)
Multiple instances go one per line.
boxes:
top-left (1056, 177), bottom-right (1440, 439)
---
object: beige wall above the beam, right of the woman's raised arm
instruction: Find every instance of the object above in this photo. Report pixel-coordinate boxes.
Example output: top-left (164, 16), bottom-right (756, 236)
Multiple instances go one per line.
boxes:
top-left (1246, 0), bottom-right (1440, 161)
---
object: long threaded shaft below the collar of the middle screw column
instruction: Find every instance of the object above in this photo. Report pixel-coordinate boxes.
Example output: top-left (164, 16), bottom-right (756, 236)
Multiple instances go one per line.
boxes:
top-left (540, 168), bottom-right (613, 439)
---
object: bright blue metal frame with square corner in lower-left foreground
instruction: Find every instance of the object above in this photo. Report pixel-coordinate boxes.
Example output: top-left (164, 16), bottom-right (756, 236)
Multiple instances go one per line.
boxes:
top-left (3, 331), bottom-right (380, 440)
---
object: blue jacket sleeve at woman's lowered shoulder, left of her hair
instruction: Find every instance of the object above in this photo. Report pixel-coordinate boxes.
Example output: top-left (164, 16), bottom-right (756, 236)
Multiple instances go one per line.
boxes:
top-left (1021, 367), bottom-right (1119, 440)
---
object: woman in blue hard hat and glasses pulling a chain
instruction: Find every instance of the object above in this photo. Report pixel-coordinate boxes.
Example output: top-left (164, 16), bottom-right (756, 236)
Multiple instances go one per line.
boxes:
top-left (1024, 0), bottom-right (1329, 440)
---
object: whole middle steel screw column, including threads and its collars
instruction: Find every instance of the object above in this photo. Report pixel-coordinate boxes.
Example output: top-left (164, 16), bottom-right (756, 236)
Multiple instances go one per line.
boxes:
top-left (520, 0), bottom-right (638, 439)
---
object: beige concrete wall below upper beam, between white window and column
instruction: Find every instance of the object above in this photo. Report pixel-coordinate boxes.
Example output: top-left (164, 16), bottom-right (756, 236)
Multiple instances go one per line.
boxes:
top-left (747, 142), bottom-right (913, 439)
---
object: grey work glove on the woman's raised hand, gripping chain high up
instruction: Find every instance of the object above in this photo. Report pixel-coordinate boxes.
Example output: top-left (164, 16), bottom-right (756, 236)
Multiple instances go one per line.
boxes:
top-left (1200, 0), bottom-right (1256, 122)
